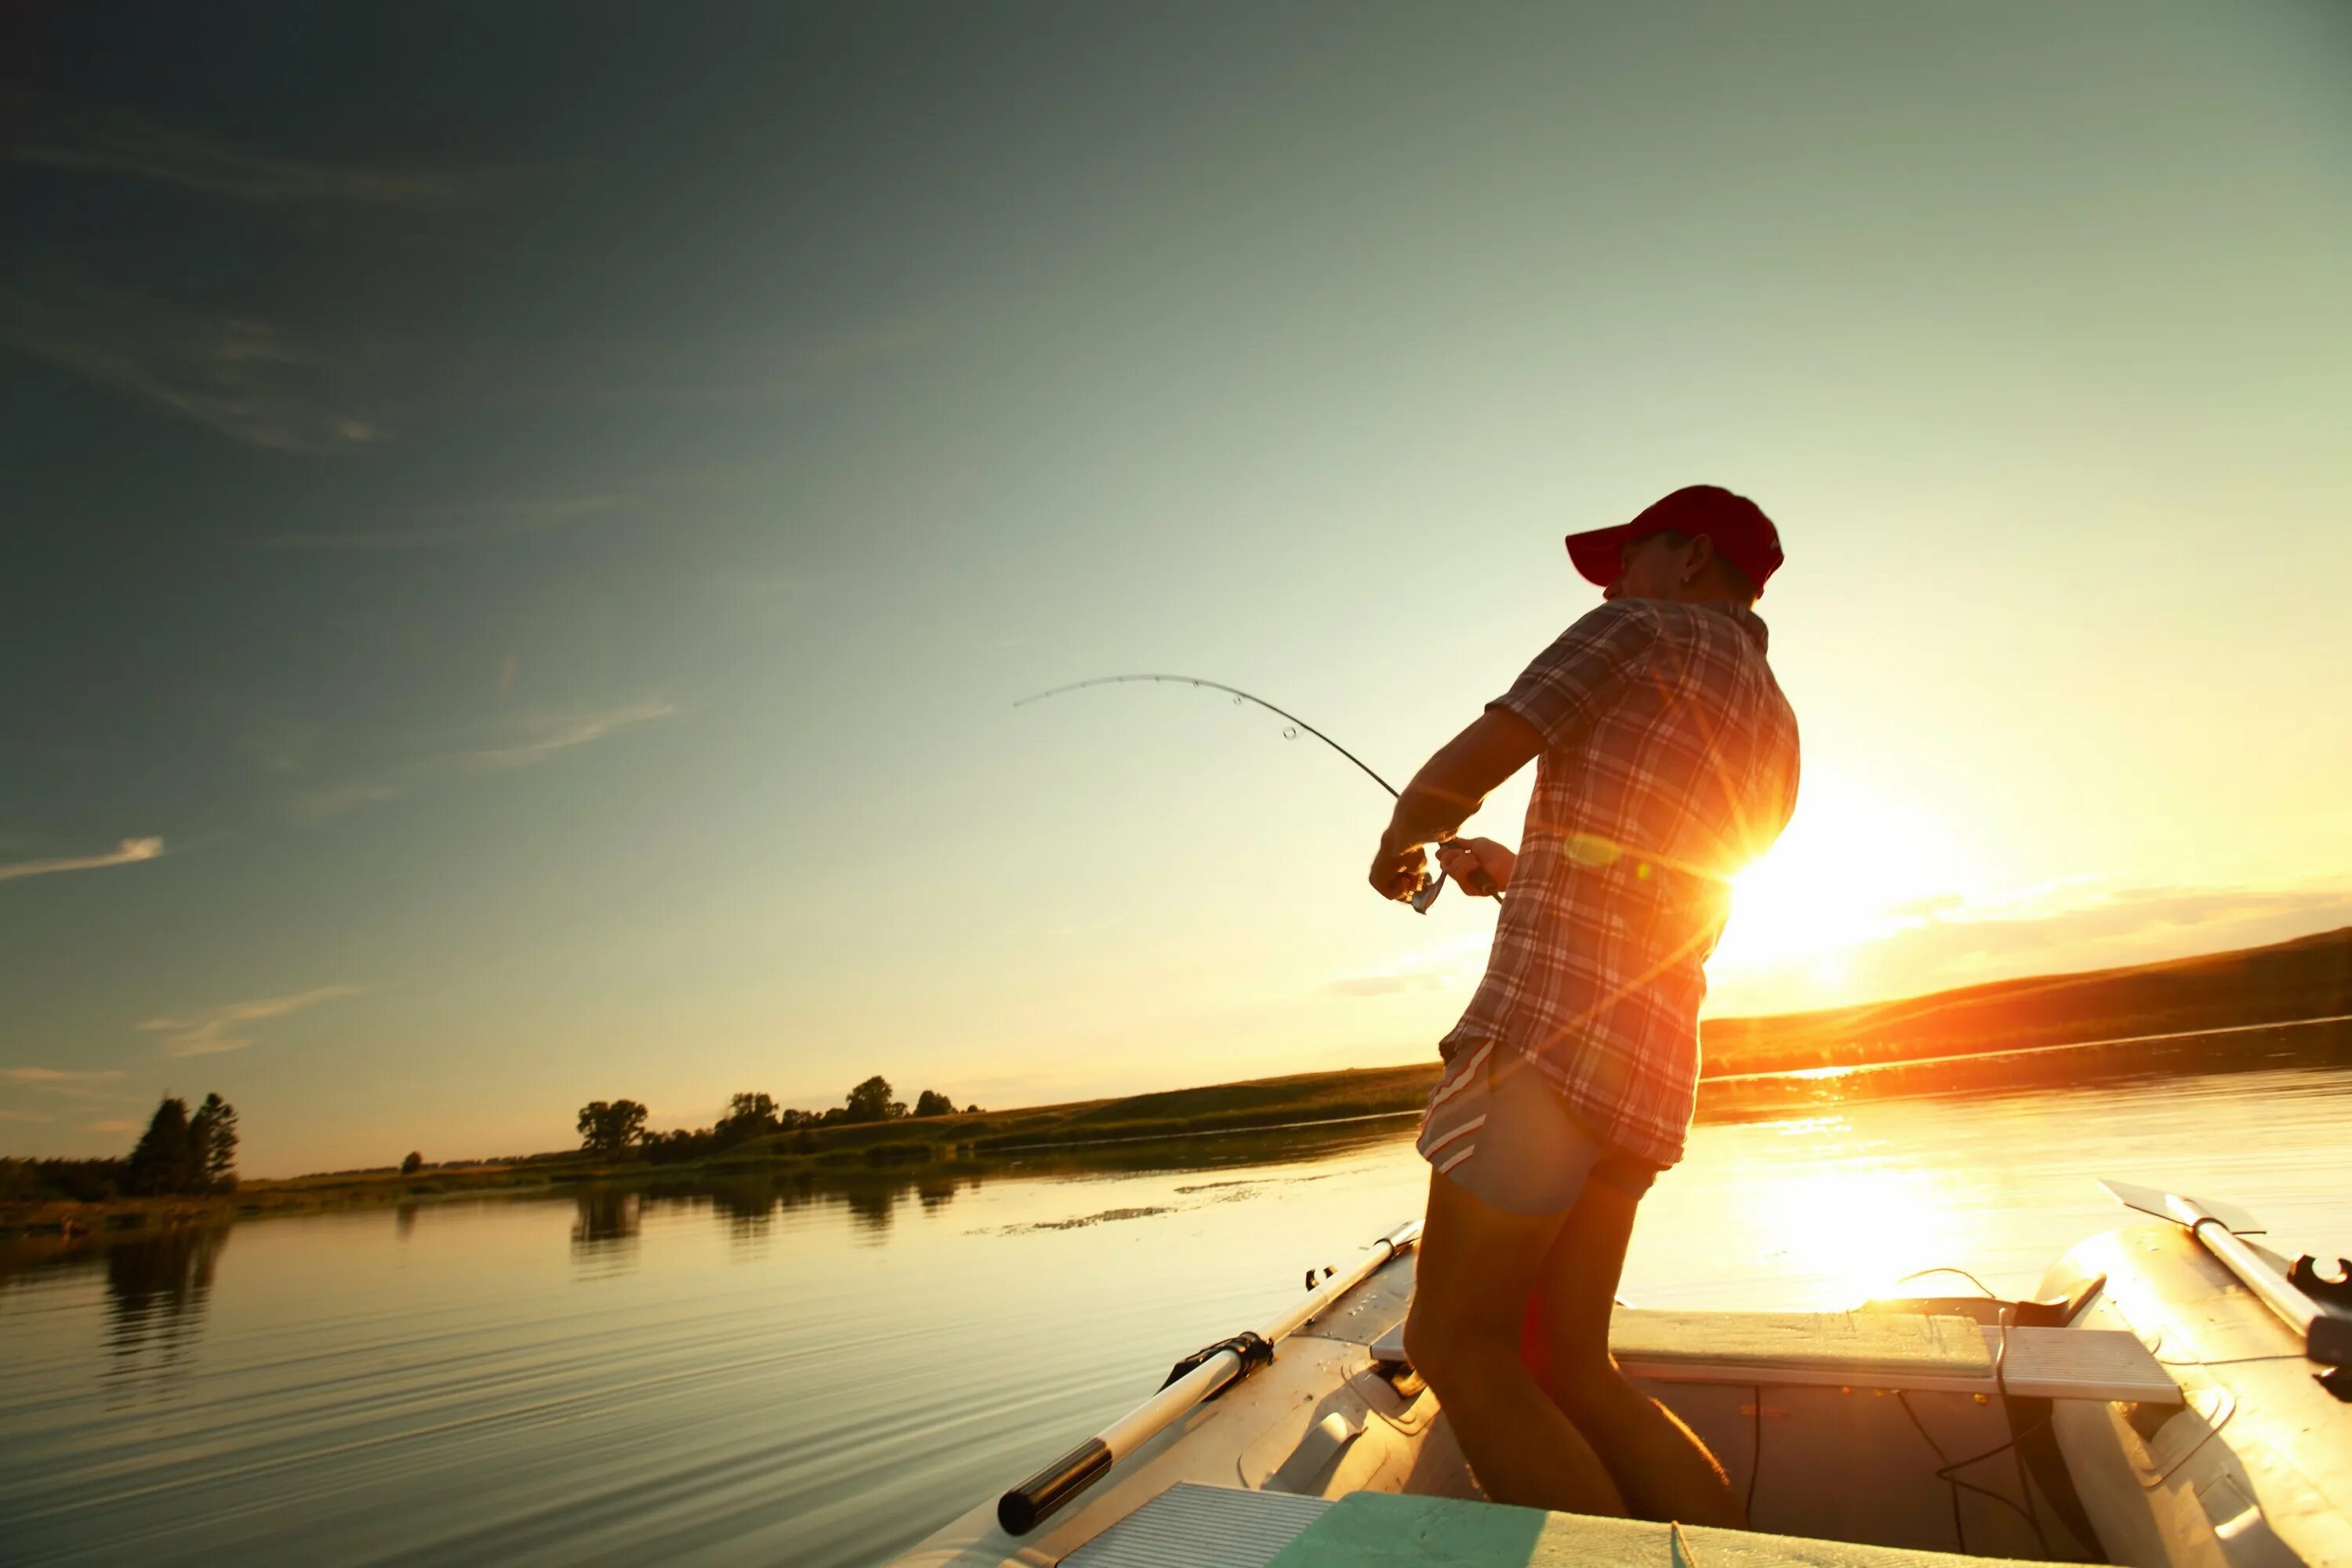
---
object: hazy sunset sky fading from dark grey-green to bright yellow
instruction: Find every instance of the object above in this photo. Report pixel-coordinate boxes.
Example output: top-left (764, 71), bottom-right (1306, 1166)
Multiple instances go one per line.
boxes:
top-left (0, 0), bottom-right (2352, 1175)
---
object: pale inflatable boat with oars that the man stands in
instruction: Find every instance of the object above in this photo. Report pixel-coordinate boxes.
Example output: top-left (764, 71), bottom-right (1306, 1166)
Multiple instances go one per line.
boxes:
top-left (898, 1182), bottom-right (2352, 1568)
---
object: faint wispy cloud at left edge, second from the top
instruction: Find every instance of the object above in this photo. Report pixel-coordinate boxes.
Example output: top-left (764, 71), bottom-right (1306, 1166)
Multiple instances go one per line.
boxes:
top-left (0, 275), bottom-right (390, 454)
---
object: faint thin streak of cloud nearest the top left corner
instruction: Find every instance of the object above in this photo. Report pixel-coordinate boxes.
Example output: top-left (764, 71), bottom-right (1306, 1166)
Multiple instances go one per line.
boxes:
top-left (0, 94), bottom-right (513, 209)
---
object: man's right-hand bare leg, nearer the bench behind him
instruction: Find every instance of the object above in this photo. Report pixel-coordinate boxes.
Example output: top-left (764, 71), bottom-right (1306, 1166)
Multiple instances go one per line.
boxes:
top-left (1524, 1182), bottom-right (1748, 1530)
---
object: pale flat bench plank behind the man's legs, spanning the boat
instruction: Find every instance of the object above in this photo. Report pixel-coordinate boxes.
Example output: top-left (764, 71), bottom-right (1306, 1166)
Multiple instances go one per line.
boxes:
top-left (1371, 1307), bottom-right (2180, 1406)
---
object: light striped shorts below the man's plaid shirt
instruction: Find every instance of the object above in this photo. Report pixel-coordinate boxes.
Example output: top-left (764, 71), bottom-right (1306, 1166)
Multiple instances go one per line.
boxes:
top-left (1414, 1041), bottom-right (1658, 1213)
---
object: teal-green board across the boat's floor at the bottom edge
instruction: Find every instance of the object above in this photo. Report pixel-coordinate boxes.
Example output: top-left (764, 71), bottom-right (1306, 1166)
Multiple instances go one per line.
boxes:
top-left (1270, 1493), bottom-right (2079, 1568)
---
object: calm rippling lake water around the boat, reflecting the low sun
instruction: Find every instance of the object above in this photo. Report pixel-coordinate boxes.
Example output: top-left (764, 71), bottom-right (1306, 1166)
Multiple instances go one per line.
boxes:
top-left (0, 1069), bottom-right (2352, 1566)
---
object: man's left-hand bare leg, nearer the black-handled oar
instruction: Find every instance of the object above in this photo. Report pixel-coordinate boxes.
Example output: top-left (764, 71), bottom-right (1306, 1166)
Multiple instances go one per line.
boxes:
top-left (1404, 1171), bottom-right (1625, 1514)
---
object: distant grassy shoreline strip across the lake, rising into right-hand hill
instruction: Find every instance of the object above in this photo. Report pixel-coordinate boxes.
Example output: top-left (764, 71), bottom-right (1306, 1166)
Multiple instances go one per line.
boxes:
top-left (0, 926), bottom-right (2352, 1236)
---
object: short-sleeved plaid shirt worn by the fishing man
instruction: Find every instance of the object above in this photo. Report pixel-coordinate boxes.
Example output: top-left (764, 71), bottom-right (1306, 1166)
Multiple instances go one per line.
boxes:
top-left (1439, 600), bottom-right (1797, 1166)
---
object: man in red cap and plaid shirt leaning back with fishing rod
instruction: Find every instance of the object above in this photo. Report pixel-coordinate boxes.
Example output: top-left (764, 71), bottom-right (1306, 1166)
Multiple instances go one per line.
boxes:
top-left (1371, 485), bottom-right (1797, 1526)
